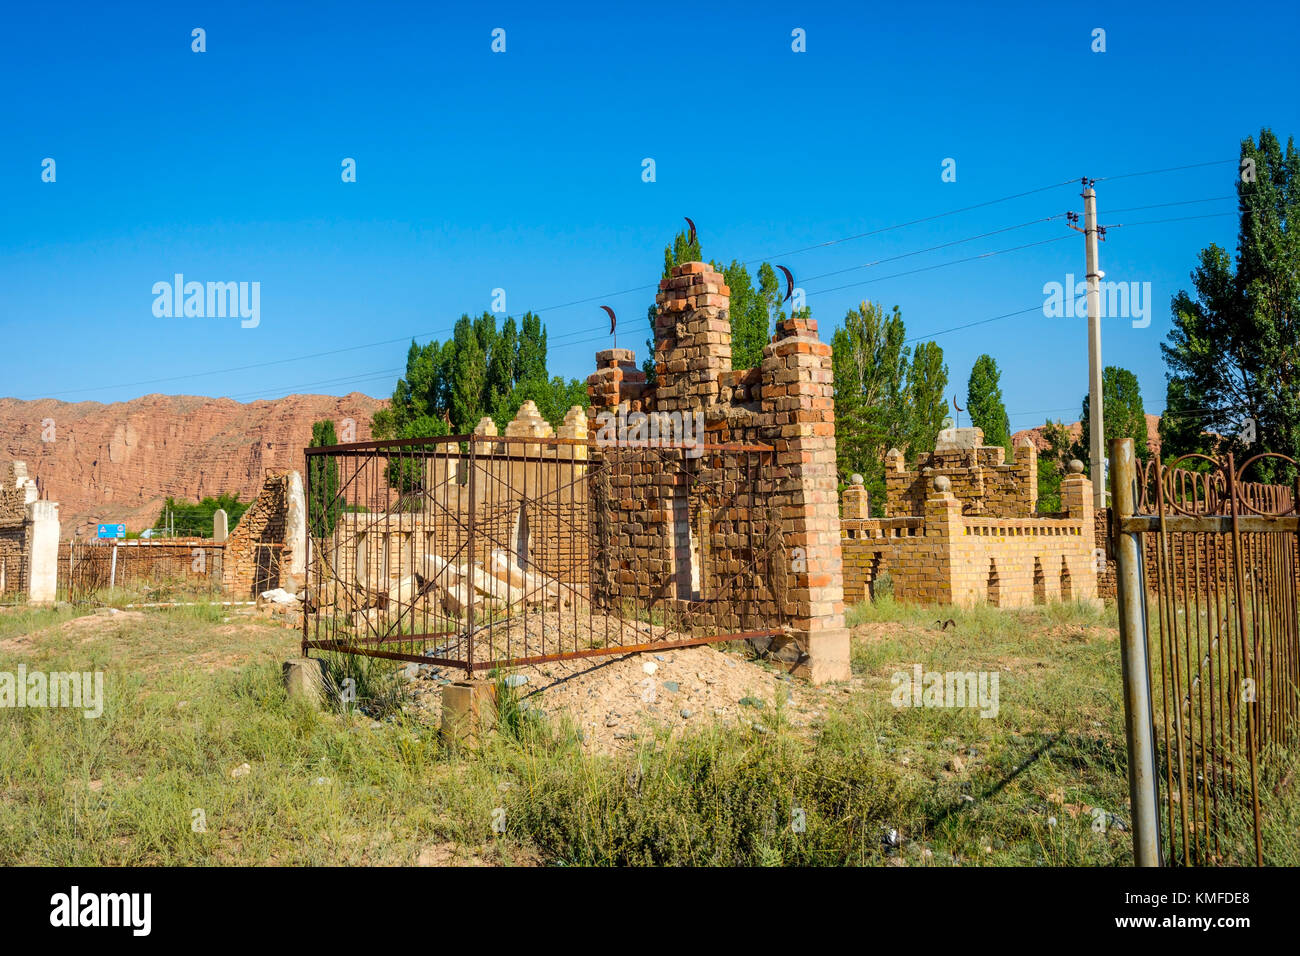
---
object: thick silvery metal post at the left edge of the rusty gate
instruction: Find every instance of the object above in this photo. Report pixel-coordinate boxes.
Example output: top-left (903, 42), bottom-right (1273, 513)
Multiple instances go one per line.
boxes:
top-left (1110, 438), bottom-right (1161, 866)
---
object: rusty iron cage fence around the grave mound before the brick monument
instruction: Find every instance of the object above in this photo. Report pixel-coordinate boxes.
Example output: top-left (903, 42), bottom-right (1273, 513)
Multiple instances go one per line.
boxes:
top-left (303, 434), bottom-right (785, 676)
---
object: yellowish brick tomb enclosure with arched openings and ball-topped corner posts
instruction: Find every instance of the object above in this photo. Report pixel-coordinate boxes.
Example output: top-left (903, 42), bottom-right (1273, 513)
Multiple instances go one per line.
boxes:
top-left (841, 428), bottom-right (1097, 607)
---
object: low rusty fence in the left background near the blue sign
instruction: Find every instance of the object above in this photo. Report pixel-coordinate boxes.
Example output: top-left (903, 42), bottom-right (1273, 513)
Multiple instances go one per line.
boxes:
top-left (57, 538), bottom-right (225, 602)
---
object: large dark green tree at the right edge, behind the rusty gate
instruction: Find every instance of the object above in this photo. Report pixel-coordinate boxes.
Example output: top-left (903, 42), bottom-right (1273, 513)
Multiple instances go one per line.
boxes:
top-left (1161, 129), bottom-right (1300, 481)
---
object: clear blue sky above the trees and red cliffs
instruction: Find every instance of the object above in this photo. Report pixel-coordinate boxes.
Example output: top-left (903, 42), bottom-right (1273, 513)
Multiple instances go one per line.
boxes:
top-left (0, 3), bottom-right (1300, 428)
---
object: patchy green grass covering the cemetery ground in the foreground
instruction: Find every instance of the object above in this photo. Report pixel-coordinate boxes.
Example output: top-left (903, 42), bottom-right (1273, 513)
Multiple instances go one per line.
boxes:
top-left (0, 598), bottom-right (1296, 865)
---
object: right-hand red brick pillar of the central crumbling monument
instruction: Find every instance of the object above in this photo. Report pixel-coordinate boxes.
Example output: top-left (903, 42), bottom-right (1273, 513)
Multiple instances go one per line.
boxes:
top-left (762, 312), bottom-right (849, 683)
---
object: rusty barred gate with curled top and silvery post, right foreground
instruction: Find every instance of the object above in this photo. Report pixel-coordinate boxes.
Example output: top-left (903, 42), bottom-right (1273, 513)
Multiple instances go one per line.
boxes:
top-left (1110, 440), bottom-right (1300, 866)
